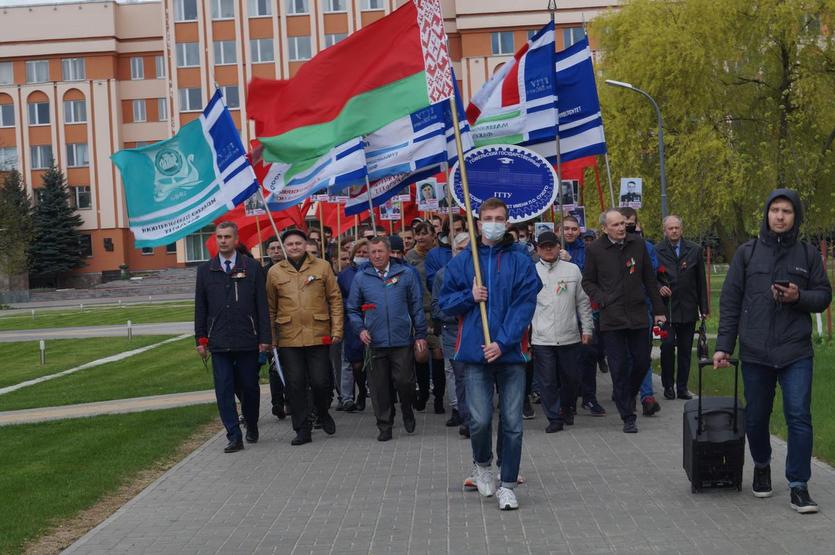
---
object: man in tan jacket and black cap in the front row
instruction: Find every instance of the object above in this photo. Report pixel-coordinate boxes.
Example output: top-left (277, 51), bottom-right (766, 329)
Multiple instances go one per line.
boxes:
top-left (267, 229), bottom-right (343, 445)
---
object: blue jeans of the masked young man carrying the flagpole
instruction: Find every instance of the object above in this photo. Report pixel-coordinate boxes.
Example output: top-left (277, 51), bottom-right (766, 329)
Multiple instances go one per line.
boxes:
top-left (464, 363), bottom-right (525, 489)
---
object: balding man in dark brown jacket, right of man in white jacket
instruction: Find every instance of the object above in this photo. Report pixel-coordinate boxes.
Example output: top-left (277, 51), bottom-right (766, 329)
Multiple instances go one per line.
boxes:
top-left (583, 208), bottom-right (667, 434)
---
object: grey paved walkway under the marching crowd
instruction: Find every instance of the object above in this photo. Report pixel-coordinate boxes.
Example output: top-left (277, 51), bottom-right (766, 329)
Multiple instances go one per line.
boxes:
top-left (67, 376), bottom-right (835, 555)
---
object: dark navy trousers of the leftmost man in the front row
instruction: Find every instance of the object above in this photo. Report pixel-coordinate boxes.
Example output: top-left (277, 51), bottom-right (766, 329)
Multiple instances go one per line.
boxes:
top-left (212, 351), bottom-right (261, 441)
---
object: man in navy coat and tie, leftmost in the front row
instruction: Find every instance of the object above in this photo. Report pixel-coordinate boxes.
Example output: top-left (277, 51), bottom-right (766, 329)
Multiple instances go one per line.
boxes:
top-left (194, 222), bottom-right (272, 453)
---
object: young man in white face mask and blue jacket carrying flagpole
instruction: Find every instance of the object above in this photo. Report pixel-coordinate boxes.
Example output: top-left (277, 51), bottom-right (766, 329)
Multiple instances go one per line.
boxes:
top-left (440, 198), bottom-right (542, 510)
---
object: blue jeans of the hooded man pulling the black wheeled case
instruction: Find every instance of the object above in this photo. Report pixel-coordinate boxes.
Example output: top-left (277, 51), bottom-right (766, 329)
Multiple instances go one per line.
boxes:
top-left (742, 357), bottom-right (812, 487)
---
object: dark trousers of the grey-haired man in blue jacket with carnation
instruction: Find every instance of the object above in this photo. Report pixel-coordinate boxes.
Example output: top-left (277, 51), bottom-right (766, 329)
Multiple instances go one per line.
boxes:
top-left (368, 346), bottom-right (416, 431)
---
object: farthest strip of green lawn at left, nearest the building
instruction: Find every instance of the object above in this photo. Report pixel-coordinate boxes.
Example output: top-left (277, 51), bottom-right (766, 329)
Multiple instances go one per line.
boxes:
top-left (0, 301), bottom-right (194, 330)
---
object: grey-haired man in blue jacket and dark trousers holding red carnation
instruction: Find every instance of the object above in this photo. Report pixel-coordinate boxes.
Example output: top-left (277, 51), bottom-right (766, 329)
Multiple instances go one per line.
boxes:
top-left (347, 237), bottom-right (427, 441)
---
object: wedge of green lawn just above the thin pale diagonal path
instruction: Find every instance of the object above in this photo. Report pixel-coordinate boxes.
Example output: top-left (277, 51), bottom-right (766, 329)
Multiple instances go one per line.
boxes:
top-left (0, 335), bottom-right (172, 388)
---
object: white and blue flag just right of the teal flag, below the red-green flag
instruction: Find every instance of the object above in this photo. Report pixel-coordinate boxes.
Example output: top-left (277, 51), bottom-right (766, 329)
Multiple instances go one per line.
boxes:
top-left (259, 138), bottom-right (367, 211)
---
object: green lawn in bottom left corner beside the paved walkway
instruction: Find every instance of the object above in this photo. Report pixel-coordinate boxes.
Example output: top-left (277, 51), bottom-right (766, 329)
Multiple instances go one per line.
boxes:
top-left (0, 405), bottom-right (217, 553)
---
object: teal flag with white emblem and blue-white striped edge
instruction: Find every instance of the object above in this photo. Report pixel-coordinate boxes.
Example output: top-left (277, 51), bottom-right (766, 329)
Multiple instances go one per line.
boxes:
top-left (111, 90), bottom-right (258, 248)
